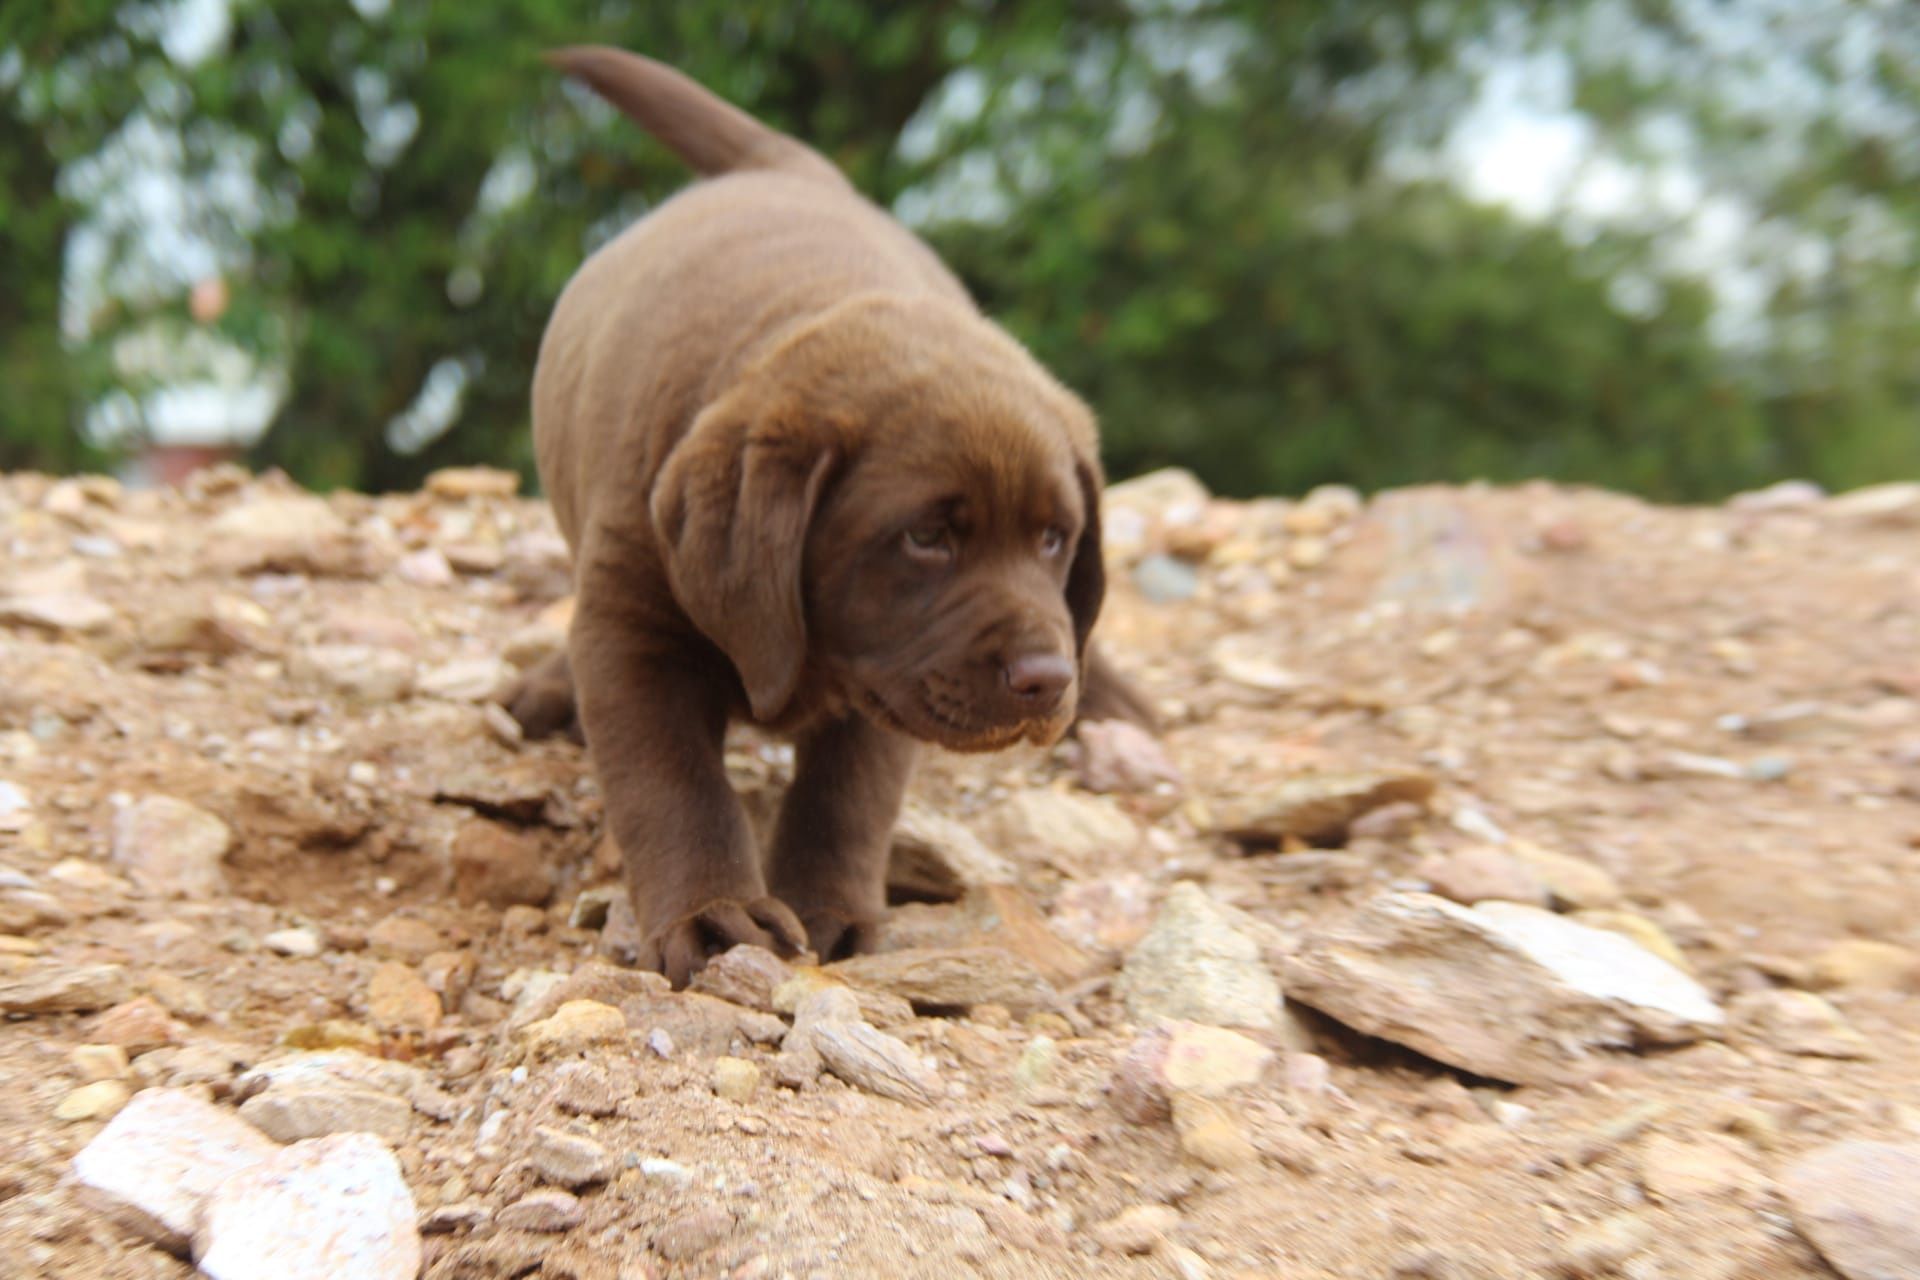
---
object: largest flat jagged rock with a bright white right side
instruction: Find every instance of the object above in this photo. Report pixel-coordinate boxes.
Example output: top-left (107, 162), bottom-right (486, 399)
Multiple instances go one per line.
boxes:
top-left (1286, 892), bottom-right (1724, 1084)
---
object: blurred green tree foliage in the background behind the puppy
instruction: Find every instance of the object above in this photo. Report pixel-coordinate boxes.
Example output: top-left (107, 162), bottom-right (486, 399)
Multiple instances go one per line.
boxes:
top-left (0, 0), bottom-right (1920, 497)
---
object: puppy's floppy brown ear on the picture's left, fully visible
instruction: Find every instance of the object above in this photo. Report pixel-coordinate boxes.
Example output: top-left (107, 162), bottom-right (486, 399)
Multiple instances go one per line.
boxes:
top-left (651, 391), bottom-right (835, 720)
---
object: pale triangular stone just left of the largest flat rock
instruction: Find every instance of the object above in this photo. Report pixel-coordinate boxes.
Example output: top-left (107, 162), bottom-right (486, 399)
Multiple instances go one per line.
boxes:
top-left (1117, 881), bottom-right (1283, 1031)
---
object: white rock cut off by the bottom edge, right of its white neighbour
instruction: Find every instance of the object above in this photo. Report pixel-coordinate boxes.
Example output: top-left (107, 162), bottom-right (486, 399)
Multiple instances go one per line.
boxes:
top-left (194, 1134), bottom-right (420, 1280)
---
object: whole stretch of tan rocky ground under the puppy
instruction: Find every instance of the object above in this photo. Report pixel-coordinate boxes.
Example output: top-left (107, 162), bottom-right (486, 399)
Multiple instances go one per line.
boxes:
top-left (0, 462), bottom-right (1920, 1280)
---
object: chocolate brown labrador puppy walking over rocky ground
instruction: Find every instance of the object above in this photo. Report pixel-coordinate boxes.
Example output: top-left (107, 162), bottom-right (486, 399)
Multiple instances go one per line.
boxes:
top-left (511, 48), bottom-right (1144, 984)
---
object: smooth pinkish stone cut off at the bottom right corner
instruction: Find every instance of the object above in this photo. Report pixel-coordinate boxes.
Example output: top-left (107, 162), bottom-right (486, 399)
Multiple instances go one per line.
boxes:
top-left (1780, 1142), bottom-right (1920, 1280)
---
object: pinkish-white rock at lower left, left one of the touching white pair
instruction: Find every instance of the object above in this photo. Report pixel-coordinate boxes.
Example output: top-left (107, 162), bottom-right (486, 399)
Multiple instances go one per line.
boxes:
top-left (73, 1088), bottom-right (278, 1251)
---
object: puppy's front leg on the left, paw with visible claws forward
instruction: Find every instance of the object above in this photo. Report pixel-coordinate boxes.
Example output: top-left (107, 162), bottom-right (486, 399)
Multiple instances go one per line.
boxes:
top-left (572, 601), bottom-right (806, 986)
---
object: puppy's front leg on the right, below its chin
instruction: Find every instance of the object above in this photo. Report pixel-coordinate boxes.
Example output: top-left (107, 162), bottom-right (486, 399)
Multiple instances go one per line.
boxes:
top-left (770, 716), bottom-right (916, 963)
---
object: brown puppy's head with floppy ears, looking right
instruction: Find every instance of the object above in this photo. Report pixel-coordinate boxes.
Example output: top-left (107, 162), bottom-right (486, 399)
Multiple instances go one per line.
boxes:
top-left (653, 297), bottom-right (1106, 750)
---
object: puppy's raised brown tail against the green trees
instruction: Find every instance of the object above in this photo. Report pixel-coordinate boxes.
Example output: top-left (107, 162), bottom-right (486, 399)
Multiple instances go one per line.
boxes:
top-left (545, 44), bottom-right (847, 186)
